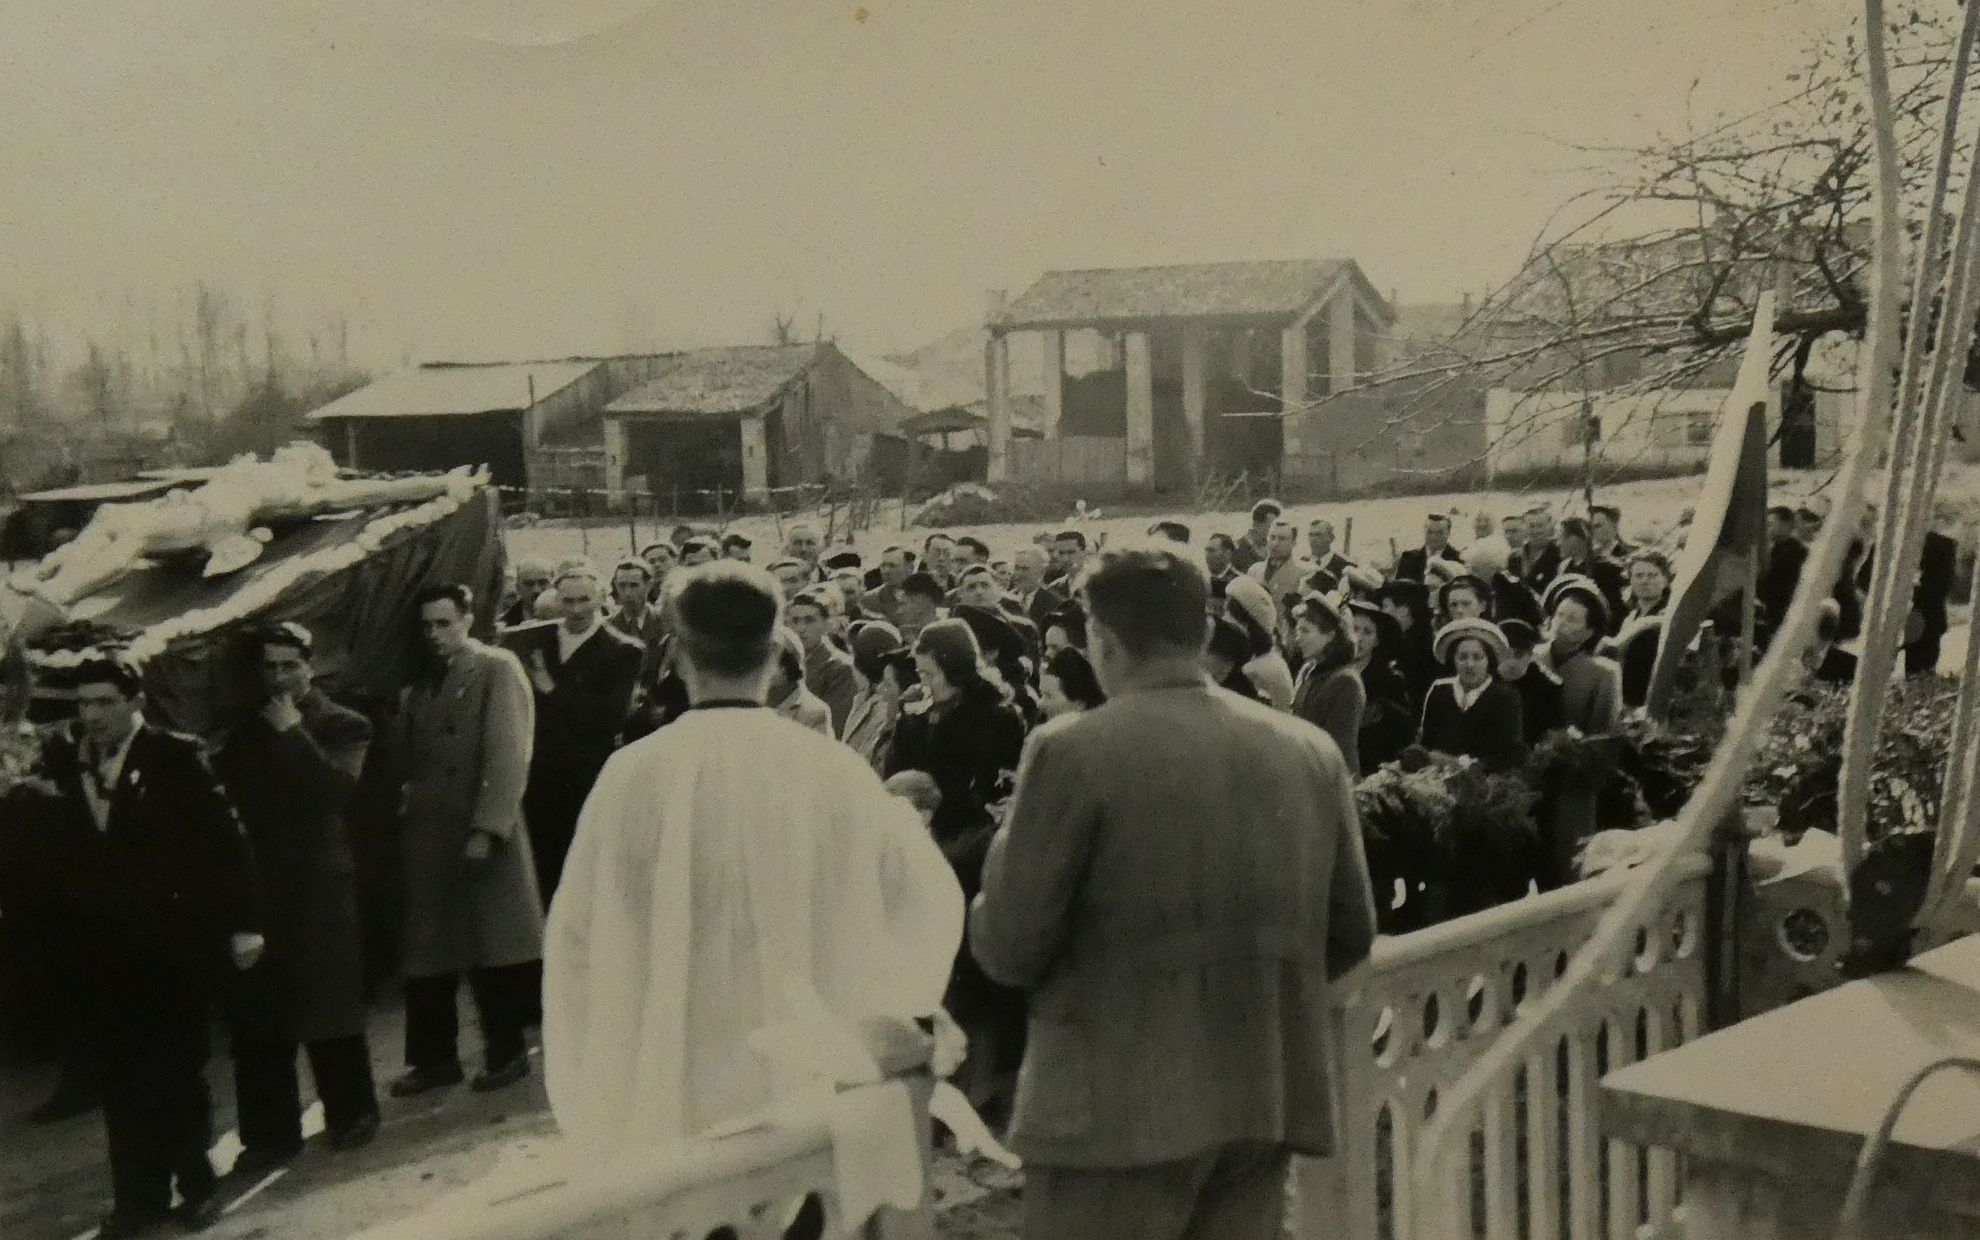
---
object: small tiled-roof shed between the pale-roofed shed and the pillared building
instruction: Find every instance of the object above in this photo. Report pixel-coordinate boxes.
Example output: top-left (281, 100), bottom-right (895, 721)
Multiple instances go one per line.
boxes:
top-left (604, 343), bottom-right (915, 511)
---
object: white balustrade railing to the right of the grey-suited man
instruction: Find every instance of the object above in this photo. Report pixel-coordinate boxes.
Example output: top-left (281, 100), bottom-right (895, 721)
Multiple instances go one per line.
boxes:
top-left (1295, 856), bottom-right (1711, 1240)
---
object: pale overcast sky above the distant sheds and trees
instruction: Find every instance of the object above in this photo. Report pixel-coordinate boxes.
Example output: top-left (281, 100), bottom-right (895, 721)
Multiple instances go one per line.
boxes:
top-left (0, 0), bottom-right (1851, 364)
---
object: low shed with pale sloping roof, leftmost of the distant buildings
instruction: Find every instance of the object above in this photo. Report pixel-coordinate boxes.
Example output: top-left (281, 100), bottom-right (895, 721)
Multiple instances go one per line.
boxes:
top-left (307, 359), bottom-right (605, 491)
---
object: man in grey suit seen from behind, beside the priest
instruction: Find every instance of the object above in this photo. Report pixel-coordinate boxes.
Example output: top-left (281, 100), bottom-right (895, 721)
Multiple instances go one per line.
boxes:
top-left (970, 549), bottom-right (1374, 1240)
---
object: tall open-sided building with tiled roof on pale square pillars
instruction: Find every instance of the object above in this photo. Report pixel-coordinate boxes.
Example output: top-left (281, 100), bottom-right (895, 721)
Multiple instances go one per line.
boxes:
top-left (984, 259), bottom-right (1394, 489)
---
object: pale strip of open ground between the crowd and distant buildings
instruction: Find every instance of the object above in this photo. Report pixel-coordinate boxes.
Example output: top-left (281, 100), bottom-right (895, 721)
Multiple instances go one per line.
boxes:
top-left (509, 464), bottom-right (1980, 578)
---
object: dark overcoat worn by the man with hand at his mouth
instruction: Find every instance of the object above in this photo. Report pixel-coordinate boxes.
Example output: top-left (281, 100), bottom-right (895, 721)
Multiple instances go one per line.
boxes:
top-left (214, 693), bottom-right (372, 1042)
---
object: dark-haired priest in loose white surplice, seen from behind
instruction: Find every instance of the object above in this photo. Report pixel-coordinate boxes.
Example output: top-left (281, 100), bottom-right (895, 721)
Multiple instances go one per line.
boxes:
top-left (543, 561), bottom-right (962, 1153)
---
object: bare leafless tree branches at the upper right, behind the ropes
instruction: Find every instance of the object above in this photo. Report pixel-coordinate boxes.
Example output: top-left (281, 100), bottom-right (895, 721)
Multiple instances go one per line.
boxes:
top-left (1338, 6), bottom-right (1974, 485)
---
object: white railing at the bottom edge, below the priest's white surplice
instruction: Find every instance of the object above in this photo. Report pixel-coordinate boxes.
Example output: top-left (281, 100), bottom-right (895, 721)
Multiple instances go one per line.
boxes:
top-left (352, 1078), bottom-right (933, 1240)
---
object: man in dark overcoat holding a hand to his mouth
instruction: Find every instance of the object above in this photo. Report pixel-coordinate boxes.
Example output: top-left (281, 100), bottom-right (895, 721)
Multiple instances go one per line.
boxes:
top-left (214, 625), bottom-right (382, 1177)
